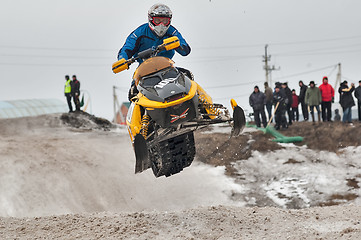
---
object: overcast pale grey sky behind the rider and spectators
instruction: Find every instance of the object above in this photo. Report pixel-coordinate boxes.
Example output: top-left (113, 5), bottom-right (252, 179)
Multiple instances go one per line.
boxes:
top-left (0, 0), bottom-right (361, 119)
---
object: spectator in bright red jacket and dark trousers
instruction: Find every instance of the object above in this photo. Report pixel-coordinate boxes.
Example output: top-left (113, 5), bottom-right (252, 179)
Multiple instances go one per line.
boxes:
top-left (318, 77), bottom-right (335, 122)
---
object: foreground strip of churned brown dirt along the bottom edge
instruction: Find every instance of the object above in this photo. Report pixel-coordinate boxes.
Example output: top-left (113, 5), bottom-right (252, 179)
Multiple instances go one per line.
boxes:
top-left (0, 205), bottom-right (361, 240)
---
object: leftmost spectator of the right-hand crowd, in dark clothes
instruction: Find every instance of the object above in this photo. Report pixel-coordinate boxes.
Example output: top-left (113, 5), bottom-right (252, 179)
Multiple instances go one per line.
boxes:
top-left (249, 86), bottom-right (267, 127)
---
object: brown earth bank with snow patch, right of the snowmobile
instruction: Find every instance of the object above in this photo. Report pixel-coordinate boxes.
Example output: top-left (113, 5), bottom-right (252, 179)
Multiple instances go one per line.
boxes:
top-left (196, 122), bottom-right (361, 209)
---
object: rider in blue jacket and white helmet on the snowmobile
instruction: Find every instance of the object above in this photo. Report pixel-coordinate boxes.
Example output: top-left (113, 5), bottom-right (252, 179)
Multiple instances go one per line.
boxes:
top-left (118, 4), bottom-right (191, 100)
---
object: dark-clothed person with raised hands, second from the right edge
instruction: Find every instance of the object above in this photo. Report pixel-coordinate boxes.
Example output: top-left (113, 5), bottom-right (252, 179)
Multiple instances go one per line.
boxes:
top-left (338, 81), bottom-right (355, 123)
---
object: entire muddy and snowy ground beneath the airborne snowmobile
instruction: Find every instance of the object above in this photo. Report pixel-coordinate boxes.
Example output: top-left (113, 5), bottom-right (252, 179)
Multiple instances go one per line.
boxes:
top-left (0, 113), bottom-right (361, 240)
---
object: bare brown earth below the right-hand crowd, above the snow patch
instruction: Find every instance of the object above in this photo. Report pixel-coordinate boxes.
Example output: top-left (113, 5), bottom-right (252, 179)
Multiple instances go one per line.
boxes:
top-left (195, 122), bottom-right (361, 176)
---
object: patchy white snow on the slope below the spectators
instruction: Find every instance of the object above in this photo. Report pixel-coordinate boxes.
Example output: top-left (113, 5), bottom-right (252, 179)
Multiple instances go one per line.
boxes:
top-left (235, 144), bottom-right (361, 208)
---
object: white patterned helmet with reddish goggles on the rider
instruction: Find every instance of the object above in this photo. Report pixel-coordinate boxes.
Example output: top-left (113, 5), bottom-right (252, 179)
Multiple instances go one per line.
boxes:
top-left (148, 3), bottom-right (172, 37)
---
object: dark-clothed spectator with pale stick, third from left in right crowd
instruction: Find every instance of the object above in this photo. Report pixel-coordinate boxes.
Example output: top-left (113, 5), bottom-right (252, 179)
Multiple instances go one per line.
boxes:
top-left (273, 84), bottom-right (288, 130)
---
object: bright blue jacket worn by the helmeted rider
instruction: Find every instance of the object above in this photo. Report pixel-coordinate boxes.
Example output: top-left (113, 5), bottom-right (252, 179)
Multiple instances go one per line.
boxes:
top-left (118, 23), bottom-right (191, 63)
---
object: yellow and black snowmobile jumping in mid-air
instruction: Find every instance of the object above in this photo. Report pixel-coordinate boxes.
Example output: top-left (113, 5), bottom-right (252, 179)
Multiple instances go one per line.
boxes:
top-left (112, 37), bottom-right (246, 177)
